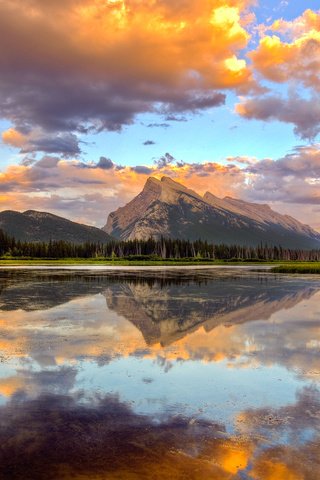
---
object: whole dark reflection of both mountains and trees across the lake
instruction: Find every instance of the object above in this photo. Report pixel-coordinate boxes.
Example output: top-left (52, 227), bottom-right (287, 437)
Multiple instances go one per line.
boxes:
top-left (0, 270), bottom-right (320, 345)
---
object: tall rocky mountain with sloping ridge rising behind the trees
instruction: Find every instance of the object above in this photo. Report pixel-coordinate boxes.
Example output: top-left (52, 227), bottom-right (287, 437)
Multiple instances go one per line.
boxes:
top-left (103, 177), bottom-right (320, 249)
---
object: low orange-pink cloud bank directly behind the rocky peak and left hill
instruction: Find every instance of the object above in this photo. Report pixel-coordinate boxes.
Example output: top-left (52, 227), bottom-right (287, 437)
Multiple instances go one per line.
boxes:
top-left (0, 157), bottom-right (244, 226)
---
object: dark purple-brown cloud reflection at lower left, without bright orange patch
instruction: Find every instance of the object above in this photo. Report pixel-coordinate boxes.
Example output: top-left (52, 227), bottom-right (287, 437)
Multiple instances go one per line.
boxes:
top-left (0, 396), bottom-right (232, 480)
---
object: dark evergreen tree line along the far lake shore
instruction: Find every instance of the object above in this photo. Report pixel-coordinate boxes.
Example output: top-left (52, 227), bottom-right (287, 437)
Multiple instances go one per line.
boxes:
top-left (0, 230), bottom-right (320, 261)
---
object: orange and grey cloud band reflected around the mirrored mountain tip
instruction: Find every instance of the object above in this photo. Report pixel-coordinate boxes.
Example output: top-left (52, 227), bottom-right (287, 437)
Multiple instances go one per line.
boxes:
top-left (0, 294), bottom-right (320, 381)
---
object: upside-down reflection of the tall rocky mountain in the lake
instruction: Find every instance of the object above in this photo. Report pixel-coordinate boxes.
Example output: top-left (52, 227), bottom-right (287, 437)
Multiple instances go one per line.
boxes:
top-left (105, 276), bottom-right (320, 346)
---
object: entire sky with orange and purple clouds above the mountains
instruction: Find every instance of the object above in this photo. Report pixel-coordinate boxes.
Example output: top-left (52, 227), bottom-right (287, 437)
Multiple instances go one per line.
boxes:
top-left (0, 0), bottom-right (320, 231)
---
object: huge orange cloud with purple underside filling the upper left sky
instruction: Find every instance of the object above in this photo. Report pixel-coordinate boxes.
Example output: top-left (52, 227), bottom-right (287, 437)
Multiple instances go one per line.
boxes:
top-left (0, 0), bottom-right (253, 154)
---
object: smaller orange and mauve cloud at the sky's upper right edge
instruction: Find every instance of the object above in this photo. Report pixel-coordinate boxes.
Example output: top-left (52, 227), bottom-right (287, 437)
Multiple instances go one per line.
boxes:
top-left (236, 9), bottom-right (320, 140)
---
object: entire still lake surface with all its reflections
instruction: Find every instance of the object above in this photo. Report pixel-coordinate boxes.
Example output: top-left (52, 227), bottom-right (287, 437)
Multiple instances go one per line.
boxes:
top-left (0, 268), bottom-right (320, 480)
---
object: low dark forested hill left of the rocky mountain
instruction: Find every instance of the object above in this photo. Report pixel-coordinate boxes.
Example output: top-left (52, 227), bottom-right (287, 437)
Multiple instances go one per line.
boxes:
top-left (0, 210), bottom-right (110, 243)
